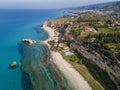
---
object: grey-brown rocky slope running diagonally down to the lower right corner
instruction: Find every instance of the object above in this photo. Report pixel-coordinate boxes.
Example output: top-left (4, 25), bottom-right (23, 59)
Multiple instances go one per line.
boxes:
top-left (71, 44), bottom-right (120, 90)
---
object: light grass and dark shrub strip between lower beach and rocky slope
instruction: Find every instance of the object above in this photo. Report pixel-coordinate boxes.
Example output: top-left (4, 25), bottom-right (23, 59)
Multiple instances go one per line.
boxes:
top-left (62, 54), bottom-right (117, 90)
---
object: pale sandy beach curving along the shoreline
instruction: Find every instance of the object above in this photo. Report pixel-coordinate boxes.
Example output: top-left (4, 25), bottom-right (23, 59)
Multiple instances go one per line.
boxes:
top-left (43, 22), bottom-right (92, 90)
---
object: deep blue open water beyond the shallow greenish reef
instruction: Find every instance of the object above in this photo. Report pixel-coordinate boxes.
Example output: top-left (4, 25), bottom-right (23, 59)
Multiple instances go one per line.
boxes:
top-left (0, 10), bottom-right (63, 90)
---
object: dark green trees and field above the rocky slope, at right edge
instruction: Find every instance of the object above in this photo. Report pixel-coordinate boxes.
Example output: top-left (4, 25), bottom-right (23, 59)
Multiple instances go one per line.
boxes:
top-left (85, 32), bottom-right (120, 63)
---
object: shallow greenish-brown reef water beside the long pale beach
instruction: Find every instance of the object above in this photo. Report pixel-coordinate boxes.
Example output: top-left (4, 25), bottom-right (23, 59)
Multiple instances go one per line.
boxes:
top-left (19, 44), bottom-right (74, 90)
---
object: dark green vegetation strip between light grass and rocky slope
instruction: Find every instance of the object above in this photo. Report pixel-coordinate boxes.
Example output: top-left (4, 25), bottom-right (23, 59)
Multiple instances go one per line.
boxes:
top-left (86, 64), bottom-right (117, 90)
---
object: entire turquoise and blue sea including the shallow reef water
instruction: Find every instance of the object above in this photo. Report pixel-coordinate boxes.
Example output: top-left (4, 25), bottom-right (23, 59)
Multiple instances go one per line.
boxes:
top-left (0, 10), bottom-right (73, 90)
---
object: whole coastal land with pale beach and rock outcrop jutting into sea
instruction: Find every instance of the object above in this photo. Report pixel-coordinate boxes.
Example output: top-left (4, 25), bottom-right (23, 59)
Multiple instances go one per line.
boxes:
top-left (18, 5), bottom-right (120, 90)
